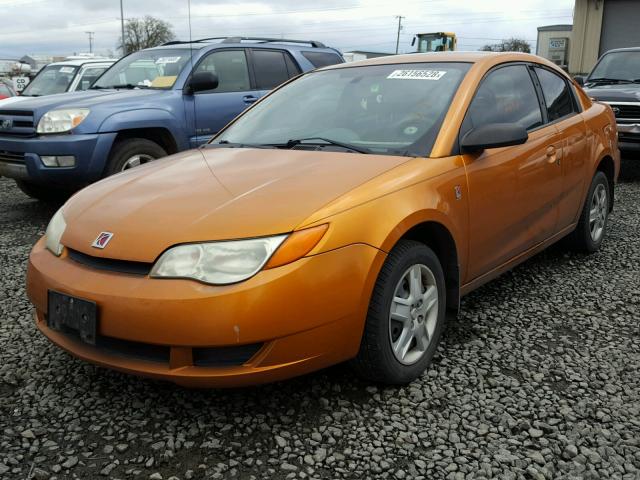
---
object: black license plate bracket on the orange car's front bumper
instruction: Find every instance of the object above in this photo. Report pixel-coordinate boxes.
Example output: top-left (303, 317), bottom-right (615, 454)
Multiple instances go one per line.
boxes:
top-left (47, 290), bottom-right (98, 345)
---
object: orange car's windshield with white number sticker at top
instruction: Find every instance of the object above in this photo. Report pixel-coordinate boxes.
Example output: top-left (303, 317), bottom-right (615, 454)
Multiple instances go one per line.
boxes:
top-left (212, 63), bottom-right (469, 155)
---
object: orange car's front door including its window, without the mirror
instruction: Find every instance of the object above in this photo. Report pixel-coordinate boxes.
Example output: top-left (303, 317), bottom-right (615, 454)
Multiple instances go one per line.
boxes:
top-left (461, 64), bottom-right (562, 282)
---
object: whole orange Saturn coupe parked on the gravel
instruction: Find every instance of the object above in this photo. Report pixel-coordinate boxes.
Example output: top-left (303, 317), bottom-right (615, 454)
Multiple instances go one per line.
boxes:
top-left (27, 52), bottom-right (620, 387)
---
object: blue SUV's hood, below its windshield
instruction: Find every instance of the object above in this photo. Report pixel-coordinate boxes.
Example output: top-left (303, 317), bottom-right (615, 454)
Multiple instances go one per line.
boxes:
top-left (0, 90), bottom-right (167, 114)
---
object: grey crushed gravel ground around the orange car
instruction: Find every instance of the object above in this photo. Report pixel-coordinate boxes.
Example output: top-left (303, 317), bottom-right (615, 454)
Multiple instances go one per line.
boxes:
top-left (0, 159), bottom-right (640, 480)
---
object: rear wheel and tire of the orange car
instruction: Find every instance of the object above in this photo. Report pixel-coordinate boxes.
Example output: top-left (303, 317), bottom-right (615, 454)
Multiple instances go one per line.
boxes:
top-left (568, 172), bottom-right (611, 253)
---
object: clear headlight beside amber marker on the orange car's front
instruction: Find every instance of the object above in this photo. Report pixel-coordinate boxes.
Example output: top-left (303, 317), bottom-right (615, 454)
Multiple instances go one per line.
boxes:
top-left (151, 235), bottom-right (287, 285)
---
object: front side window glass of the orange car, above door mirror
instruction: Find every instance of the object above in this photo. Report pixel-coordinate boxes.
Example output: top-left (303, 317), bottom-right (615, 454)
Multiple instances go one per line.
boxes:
top-left (465, 65), bottom-right (542, 130)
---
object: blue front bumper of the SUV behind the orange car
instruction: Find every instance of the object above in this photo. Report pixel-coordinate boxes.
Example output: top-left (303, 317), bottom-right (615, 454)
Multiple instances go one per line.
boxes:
top-left (0, 133), bottom-right (116, 187)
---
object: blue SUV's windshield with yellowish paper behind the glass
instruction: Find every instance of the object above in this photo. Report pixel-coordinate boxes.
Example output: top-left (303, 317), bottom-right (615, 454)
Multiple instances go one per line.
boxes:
top-left (91, 48), bottom-right (190, 89)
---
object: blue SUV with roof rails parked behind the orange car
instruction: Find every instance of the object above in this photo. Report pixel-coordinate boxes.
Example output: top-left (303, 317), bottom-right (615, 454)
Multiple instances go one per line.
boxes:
top-left (0, 37), bottom-right (344, 200)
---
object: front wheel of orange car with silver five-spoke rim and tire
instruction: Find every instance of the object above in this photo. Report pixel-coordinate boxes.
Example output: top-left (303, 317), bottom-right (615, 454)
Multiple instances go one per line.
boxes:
top-left (352, 240), bottom-right (446, 385)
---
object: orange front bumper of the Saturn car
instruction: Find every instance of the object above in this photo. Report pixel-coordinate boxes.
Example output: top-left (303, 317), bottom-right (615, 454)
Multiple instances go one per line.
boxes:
top-left (27, 240), bottom-right (385, 387)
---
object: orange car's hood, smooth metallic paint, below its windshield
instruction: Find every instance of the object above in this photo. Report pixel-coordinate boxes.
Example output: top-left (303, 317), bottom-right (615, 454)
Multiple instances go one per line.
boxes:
top-left (62, 148), bottom-right (409, 262)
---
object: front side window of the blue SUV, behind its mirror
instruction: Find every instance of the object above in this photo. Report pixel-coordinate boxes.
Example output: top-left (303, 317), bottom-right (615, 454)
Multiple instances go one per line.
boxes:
top-left (196, 50), bottom-right (251, 93)
